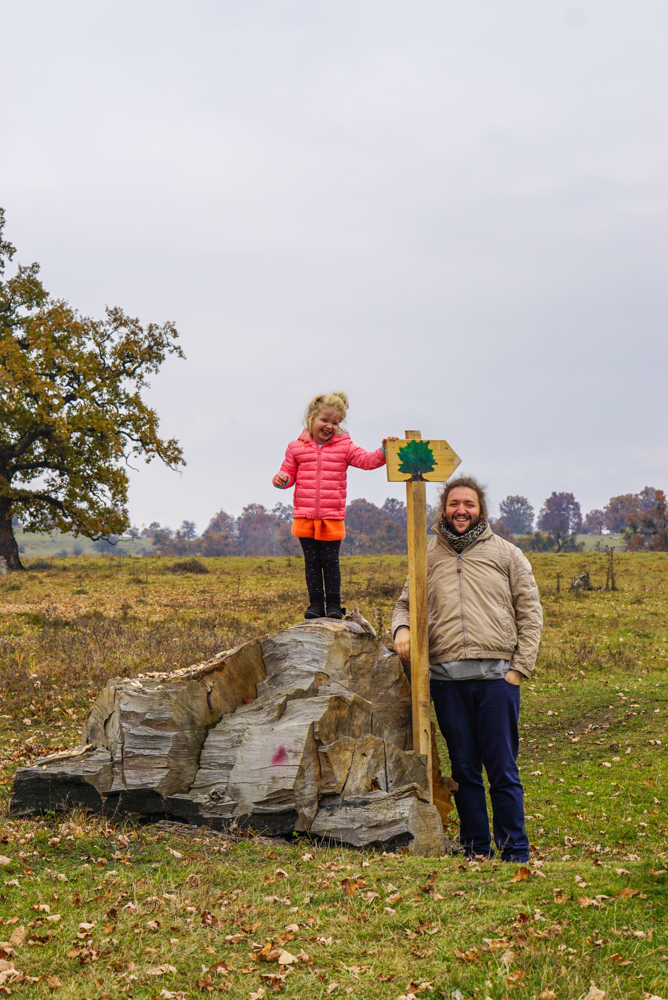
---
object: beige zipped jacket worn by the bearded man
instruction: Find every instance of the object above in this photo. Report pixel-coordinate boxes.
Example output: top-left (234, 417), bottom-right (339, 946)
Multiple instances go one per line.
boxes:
top-left (392, 527), bottom-right (543, 677)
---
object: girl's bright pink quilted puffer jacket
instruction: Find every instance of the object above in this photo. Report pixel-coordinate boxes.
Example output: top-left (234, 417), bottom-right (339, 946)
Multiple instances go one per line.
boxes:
top-left (273, 430), bottom-right (385, 521)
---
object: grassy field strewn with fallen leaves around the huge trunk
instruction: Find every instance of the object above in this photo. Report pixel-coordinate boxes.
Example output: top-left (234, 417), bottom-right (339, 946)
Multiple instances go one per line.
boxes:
top-left (0, 553), bottom-right (668, 1000)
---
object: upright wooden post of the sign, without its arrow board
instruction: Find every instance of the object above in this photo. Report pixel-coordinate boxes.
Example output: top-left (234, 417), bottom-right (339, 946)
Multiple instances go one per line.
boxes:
top-left (405, 431), bottom-right (434, 803)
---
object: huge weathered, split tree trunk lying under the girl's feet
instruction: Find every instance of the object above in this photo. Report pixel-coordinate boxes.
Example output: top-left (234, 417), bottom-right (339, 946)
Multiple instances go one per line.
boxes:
top-left (10, 620), bottom-right (460, 854)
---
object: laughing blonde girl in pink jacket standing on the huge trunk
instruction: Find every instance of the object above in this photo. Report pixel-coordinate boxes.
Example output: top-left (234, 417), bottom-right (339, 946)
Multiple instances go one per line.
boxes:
top-left (273, 392), bottom-right (396, 618)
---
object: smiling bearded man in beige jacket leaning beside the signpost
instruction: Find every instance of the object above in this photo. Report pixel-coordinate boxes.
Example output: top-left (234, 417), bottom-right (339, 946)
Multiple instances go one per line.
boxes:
top-left (392, 476), bottom-right (543, 861)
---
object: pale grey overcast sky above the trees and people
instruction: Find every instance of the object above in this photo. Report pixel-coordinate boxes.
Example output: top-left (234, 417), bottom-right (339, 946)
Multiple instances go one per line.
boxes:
top-left (0, 0), bottom-right (668, 530)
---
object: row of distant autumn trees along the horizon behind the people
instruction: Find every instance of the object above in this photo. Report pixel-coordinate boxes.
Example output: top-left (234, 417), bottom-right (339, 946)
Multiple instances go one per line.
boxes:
top-left (136, 486), bottom-right (668, 556)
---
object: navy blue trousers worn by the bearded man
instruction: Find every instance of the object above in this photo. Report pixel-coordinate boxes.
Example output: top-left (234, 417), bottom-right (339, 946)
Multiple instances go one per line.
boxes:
top-left (431, 679), bottom-right (529, 861)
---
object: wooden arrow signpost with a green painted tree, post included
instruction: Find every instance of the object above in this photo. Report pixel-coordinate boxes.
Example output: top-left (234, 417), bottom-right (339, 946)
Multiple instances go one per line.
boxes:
top-left (385, 431), bottom-right (461, 802)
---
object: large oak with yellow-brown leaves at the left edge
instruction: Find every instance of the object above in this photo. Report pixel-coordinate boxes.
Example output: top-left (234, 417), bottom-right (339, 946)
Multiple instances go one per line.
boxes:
top-left (0, 209), bottom-right (184, 570)
